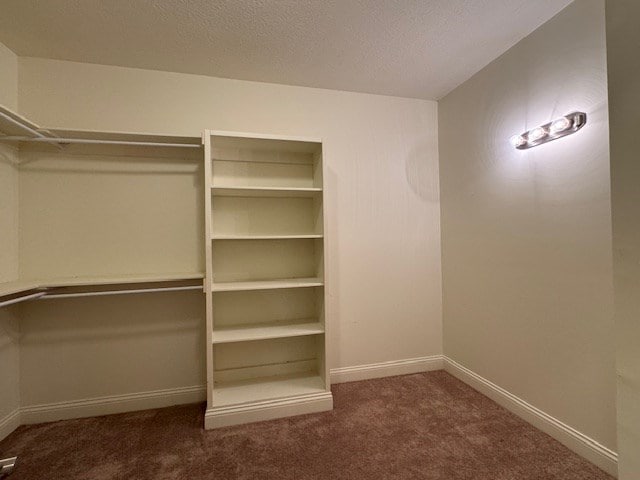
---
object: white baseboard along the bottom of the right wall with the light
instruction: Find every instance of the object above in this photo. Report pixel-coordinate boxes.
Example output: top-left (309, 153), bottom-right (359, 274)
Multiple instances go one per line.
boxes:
top-left (443, 356), bottom-right (618, 477)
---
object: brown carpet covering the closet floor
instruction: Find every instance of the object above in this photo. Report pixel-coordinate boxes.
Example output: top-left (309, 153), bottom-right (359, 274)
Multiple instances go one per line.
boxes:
top-left (0, 371), bottom-right (613, 480)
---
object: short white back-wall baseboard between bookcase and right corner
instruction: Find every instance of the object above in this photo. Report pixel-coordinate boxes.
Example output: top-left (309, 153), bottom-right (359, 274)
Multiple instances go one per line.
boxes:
top-left (331, 355), bottom-right (442, 383)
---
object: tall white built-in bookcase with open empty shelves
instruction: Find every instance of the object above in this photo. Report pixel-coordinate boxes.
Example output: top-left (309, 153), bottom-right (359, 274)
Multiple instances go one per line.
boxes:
top-left (204, 131), bottom-right (333, 428)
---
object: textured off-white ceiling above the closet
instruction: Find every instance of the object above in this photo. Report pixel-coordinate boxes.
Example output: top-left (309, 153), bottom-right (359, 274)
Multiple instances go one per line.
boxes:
top-left (0, 0), bottom-right (571, 99)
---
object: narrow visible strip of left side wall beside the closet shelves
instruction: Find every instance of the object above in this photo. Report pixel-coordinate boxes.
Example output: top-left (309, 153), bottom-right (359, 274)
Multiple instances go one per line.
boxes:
top-left (0, 43), bottom-right (20, 432)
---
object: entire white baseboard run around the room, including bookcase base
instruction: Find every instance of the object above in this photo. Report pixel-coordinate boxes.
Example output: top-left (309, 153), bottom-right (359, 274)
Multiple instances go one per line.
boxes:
top-left (0, 355), bottom-right (618, 476)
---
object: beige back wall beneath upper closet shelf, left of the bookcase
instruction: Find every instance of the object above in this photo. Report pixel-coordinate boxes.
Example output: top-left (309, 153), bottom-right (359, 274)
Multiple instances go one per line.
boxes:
top-left (20, 147), bottom-right (205, 410)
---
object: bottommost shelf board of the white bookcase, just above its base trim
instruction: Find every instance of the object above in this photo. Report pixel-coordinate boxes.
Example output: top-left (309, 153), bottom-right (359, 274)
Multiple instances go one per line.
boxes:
top-left (211, 373), bottom-right (326, 408)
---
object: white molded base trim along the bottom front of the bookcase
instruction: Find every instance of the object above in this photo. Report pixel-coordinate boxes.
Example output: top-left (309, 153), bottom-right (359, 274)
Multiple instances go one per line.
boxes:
top-left (204, 392), bottom-right (333, 430)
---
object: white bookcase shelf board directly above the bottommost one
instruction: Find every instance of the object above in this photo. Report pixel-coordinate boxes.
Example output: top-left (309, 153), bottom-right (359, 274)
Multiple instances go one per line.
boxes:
top-left (212, 321), bottom-right (324, 345)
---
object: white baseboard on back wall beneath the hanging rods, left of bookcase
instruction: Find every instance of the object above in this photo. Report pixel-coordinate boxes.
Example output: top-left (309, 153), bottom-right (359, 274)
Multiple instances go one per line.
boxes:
top-left (20, 385), bottom-right (206, 425)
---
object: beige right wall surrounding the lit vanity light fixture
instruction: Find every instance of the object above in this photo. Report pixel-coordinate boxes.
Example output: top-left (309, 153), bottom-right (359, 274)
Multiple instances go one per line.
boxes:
top-left (438, 0), bottom-right (616, 450)
